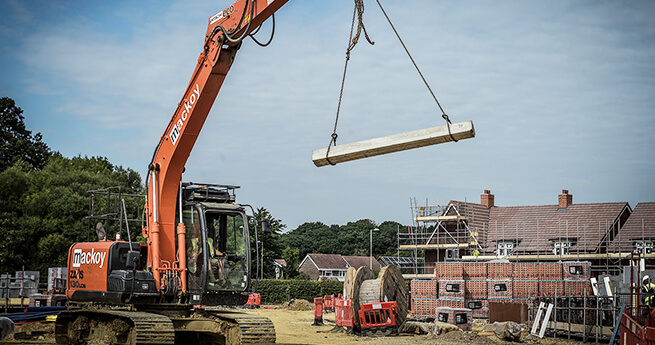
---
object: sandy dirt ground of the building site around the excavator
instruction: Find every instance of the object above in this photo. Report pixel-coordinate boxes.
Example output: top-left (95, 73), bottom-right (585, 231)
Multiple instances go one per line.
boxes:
top-left (0, 302), bottom-right (596, 345)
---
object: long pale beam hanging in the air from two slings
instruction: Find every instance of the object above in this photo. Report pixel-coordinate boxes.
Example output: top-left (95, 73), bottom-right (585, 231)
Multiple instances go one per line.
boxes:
top-left (312, 121), bottom-right (475, 167)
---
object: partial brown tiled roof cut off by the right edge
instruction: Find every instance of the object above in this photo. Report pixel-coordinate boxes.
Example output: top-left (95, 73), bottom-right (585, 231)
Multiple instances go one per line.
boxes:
top-left (610, 202), bottom-right (655, 252)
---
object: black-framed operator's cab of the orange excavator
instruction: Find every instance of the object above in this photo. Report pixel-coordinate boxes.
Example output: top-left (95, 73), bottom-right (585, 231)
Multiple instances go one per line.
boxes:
top-left (177, 183), bottom-right (251, 305)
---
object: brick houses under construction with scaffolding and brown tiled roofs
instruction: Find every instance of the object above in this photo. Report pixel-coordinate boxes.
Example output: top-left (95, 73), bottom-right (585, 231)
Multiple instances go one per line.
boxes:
top-left (398, 190), bottom-right (655, 278)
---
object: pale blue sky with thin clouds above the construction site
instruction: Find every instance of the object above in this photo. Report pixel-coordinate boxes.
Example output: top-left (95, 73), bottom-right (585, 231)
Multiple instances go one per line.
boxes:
top-left (0, 0), bottom-right (655, 229)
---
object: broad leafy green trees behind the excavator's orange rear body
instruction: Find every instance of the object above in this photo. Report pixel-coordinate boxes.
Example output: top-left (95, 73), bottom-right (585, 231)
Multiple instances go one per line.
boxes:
top-left (0, 153), bottom-right (141, 273)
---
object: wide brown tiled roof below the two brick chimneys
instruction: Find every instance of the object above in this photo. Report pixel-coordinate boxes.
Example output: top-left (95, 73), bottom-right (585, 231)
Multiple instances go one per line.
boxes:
top-left (450, 201), bottom-right (630, 252)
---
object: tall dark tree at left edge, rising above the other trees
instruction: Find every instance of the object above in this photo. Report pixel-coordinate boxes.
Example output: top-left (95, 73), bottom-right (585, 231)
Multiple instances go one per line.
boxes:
top-left (0, 97), bottom-right (51, 171)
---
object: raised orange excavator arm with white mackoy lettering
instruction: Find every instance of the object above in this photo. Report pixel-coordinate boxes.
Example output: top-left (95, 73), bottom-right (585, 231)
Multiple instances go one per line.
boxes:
top-left (143, 0), bottom-right (288, 291)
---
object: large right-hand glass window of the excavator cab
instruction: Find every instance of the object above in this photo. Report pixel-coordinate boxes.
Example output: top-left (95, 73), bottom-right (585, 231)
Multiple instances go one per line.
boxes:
top-left (205, 211), bottom-right (249, 291)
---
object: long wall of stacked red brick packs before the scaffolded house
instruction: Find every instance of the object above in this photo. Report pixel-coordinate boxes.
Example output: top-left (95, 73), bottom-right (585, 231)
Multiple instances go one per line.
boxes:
top-left (411, 262), bottom-right (591, 318)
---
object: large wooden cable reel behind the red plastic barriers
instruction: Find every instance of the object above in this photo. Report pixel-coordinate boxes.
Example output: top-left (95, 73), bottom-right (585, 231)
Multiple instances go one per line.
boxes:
top-left (343, 265), bottom-right (408, 330)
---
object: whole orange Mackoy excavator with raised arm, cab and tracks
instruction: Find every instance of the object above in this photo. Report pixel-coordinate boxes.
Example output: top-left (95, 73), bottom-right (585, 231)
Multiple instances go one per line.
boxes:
top-left (55, 0), bottom-right (288, 344)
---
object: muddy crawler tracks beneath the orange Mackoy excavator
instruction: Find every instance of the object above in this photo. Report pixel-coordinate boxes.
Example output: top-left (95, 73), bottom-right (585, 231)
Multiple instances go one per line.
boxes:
top-left (55, 308), bottom-right (276, 345)
